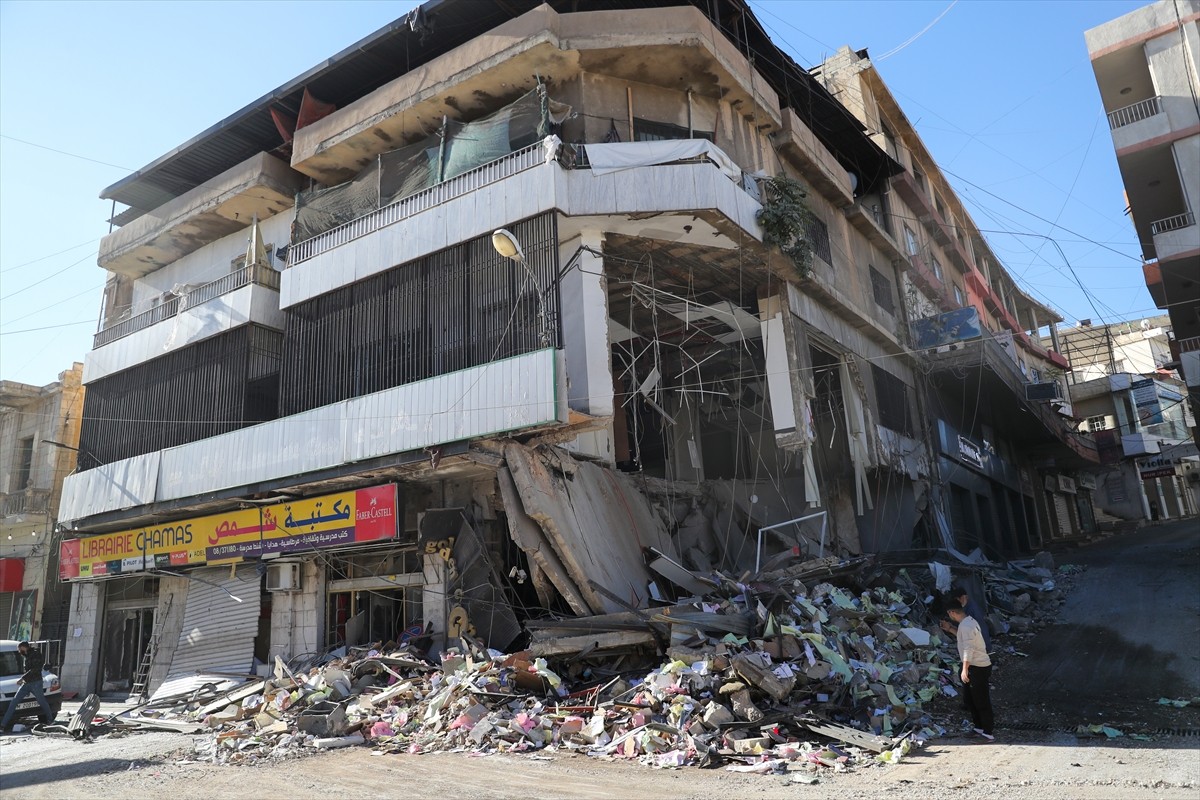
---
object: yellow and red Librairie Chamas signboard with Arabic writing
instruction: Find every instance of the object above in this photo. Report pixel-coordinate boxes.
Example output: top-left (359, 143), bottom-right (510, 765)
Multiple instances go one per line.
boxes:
top-left (59, 485), bottom-right (397, 581)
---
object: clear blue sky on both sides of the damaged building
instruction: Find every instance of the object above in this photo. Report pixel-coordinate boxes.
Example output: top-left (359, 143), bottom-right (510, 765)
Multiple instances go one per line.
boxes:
top-left (0, 0), bottom-right (1156, 384)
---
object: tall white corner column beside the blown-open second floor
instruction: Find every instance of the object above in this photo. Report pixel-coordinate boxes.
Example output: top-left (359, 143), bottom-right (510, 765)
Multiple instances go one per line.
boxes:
top-left (558, 230), bottom-right (613, 462)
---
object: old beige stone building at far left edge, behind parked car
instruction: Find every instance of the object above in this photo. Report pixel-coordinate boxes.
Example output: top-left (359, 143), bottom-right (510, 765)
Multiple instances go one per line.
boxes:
top-left (0, 363), bottom-right (84, 657)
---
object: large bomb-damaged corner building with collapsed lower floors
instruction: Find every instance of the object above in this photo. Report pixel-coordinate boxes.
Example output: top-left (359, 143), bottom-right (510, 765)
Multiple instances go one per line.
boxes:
top-left (51, 0), bottom-right (1094, 693)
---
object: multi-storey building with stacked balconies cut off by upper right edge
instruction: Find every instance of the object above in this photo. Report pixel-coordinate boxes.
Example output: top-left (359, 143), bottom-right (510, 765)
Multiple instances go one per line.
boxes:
top-left (1085, 0), bottom-right (1200, 439)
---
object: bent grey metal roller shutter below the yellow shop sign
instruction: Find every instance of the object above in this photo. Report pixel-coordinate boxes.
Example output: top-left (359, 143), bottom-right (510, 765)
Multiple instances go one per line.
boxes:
top-left (168, 567), bottom-right (260, 676)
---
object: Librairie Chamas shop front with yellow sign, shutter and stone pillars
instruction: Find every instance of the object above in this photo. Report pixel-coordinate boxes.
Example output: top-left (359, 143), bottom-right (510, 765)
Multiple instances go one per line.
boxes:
top-left (60, 483), bottom-right (408, 694)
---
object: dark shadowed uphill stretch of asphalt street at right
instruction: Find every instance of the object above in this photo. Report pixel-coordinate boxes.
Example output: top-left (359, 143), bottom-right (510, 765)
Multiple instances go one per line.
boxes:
top-left (997, 519), bottom-right (1200, 729)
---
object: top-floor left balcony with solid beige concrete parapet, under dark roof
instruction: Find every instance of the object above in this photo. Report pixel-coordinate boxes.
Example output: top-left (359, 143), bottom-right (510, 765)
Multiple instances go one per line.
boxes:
top-left (97, 152), bottom-right (305, 278)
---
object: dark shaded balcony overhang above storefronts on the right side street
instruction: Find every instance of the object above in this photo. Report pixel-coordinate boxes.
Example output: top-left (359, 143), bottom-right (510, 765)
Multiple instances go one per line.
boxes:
top-left (926, 329), bottom-right (1099, 467)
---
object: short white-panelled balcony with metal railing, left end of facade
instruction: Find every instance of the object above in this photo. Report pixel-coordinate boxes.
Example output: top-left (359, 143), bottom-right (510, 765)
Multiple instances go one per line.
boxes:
top-left (84, 265), bottom-right (283, 383)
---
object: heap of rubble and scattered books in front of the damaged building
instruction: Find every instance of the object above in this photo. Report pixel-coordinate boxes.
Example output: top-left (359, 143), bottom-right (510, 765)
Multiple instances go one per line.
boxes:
top-left (100, 546), bottom-right (1080, 781)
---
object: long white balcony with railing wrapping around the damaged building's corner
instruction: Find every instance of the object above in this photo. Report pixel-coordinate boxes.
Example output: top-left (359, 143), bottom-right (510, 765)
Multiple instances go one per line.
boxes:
top-left (281, 137), bottom-right (762, 308)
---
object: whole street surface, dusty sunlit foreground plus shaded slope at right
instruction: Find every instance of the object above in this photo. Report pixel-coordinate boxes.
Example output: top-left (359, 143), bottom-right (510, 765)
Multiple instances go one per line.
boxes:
top-left (0, 522), bottom-right (1200, 800)
